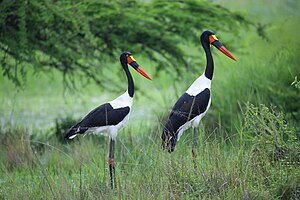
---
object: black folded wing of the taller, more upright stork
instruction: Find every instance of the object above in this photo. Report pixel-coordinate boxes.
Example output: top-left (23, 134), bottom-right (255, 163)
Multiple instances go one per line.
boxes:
top-left (165, 88), bottom-right (210, 136)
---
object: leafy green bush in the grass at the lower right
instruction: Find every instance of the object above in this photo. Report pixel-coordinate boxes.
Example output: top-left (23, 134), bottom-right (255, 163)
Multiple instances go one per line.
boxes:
top-left (243, 103), bottom-right (300, 199)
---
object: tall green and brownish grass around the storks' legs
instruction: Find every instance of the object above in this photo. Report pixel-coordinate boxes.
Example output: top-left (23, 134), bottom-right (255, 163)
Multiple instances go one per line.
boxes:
top-left (0, 104), bottom-right (300, 199)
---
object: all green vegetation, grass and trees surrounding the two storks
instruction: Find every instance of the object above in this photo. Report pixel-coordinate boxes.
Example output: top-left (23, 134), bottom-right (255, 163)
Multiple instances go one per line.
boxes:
top-left (0, 0), bottom-right (300, 199)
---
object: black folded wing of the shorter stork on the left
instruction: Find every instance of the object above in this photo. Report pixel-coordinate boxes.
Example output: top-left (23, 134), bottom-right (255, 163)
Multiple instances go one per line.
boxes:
top-left (65, 103), bottom-right (130, 138)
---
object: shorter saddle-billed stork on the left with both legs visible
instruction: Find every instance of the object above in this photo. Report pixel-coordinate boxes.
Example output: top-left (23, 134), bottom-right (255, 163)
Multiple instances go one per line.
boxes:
top-left (65, 52), bottom-right (151, 188)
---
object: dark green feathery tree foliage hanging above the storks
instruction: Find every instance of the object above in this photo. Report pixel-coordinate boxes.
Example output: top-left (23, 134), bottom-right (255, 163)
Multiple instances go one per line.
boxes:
top-left (0, 0), bottom-right (250, 85)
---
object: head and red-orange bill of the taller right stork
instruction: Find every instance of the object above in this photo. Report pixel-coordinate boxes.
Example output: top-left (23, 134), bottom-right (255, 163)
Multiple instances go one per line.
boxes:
top-left (200, 30), bottom-right (236, 61)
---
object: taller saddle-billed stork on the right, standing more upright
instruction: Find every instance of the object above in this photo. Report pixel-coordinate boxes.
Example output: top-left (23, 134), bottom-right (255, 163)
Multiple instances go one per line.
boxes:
top-left (162, 30), bottom-right (236, 158)
